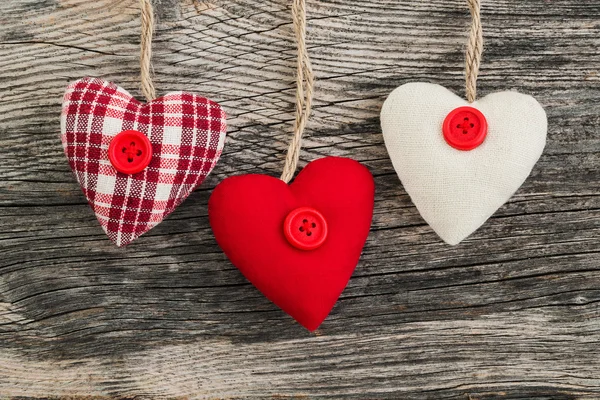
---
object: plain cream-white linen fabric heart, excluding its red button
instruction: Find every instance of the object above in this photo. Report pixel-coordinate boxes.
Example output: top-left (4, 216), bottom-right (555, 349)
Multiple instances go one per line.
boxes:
top-left (381, 83), bottom-right (547, 245)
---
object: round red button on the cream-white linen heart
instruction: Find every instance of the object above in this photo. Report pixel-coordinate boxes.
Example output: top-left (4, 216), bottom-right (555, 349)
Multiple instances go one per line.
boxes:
top-left (443, 106), bottom-right (487, 150)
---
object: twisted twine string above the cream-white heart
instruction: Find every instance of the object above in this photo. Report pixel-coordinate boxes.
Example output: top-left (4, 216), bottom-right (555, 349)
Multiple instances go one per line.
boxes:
top-left (465, 0), bottom-right (483, 103)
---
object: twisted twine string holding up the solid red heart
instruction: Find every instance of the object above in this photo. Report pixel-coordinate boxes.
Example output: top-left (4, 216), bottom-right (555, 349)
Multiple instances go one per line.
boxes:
top-left (281, 0), bottom-right (314, 183)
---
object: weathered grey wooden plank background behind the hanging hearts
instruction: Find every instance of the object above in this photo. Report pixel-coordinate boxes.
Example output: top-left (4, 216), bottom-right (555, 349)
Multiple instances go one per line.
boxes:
top-left (0, 0), bottom-right (600, 399)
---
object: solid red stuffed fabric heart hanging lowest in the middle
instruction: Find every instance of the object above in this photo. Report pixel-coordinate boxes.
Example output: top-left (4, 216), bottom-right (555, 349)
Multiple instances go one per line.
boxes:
top-left (208, 157), bottom-right (375, 331)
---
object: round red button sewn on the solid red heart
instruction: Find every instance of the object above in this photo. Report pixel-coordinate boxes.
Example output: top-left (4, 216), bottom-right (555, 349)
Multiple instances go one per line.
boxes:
top-left (283, 207), bottom-right (327, 250)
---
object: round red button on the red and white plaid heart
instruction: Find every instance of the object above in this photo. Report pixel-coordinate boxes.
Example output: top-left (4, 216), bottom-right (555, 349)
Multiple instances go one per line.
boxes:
top-left (108, 131), bottom-right (152, 174)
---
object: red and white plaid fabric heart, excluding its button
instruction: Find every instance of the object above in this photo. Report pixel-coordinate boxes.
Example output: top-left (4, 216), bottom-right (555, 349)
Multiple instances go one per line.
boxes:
top-left (61, 78), bottom-right (226, 246)
